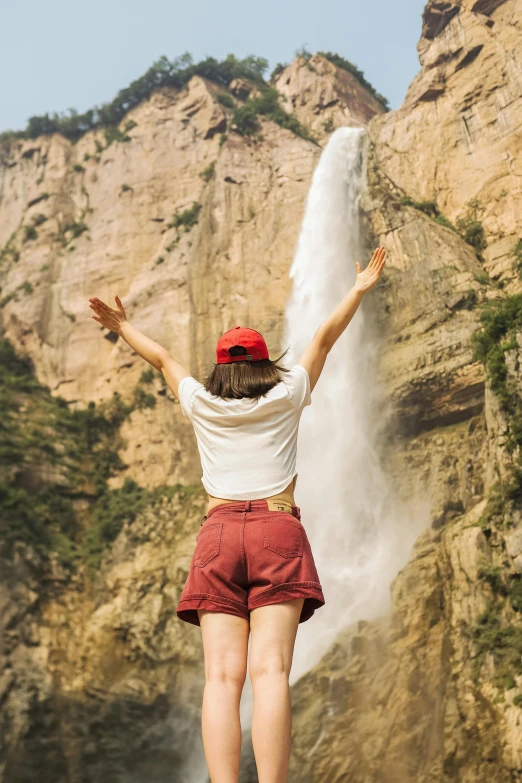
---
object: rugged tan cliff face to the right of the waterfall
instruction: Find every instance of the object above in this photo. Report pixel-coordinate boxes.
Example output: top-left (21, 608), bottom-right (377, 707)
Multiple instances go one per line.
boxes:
top-left (282, 0), bottom-right (522, 783)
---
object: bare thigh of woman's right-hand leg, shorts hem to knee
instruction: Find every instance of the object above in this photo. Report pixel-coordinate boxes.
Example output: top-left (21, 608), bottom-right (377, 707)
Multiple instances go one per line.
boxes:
top-left (248, 598), bottom-right (305, 681)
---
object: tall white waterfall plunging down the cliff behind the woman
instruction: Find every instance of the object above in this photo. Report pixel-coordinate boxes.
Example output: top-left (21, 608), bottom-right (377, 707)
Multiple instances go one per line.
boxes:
top-left (281, 128), bottom-right (429, 682)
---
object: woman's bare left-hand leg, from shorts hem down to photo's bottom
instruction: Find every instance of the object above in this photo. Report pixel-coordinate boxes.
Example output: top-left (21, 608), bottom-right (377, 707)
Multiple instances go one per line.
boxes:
top-left (198, 609), bottom-right (250, 783)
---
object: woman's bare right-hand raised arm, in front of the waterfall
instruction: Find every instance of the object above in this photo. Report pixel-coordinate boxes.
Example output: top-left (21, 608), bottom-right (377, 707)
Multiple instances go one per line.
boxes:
top-left (297, 247), bottom-right (386, 391)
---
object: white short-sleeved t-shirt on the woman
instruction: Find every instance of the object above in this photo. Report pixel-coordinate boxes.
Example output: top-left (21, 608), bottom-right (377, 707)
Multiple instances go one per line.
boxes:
top-left (178, 364), bottom-right (312, 500)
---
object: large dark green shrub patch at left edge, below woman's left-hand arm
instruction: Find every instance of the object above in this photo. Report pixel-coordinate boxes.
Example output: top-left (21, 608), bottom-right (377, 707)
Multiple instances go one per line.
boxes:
top-left (0, 339), bottom-right (203, 573)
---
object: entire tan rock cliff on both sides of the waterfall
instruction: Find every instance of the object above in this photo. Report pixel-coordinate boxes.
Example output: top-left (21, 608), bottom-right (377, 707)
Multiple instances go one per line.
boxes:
top-left (0, 0), bottom-right (522, 783)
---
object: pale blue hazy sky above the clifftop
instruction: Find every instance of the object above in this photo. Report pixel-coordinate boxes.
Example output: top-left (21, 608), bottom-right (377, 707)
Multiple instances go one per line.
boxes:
top-left (0, 0), bottom-right (425, 131)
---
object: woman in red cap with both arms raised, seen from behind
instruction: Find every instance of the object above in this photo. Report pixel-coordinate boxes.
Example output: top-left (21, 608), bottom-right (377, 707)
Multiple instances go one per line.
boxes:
top-left (89, 247), bottom-right (385, 783)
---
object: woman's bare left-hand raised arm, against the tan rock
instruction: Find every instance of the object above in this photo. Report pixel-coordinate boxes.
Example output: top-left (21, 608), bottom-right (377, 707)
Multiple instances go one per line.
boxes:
top-left (89, 296), bottom-right (190, 397)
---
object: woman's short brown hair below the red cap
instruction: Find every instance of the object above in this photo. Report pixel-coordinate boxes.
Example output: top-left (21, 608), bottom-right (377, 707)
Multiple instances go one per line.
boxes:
top-left (203, 345), bottom-right (289, 400)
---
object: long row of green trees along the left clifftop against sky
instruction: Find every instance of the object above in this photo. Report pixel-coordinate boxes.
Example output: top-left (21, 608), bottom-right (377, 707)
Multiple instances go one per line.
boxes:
top-left (3, 53), bottom-right (268, 144)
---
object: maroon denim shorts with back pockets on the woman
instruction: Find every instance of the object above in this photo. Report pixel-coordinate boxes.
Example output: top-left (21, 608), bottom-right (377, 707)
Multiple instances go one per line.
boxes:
top-left (176, 500), bottom-right (325, 625)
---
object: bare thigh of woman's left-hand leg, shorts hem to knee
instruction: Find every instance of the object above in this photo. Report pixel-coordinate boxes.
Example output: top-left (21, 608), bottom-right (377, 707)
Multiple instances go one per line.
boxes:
top-left (198, 609), bottom-right (250, 684)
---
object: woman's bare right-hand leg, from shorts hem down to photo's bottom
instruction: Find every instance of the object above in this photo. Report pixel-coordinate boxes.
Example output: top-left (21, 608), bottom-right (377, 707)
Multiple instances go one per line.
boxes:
top-left (248, 598), bottom-right (304, 783)
